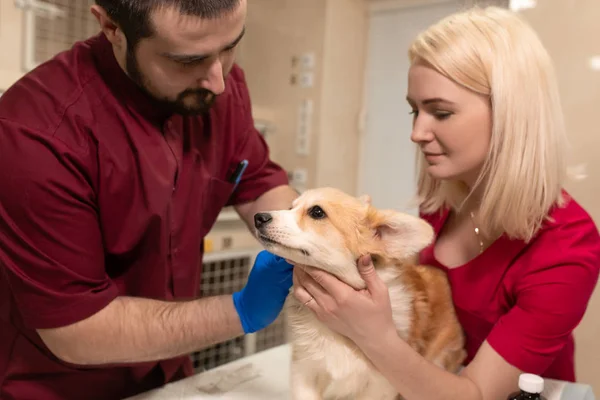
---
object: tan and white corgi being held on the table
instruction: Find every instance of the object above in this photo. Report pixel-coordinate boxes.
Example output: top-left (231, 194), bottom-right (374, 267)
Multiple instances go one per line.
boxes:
top-left (254, 188), bottom-right (466, 400)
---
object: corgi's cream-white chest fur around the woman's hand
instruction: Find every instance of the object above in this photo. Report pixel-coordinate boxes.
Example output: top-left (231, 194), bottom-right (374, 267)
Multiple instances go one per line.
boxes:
top-left (286, 268), bottom-right (412, 400)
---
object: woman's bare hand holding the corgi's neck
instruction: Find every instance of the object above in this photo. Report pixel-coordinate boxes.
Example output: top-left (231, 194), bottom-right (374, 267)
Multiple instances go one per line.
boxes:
top-left (294, 256), bottom-right (396, 346)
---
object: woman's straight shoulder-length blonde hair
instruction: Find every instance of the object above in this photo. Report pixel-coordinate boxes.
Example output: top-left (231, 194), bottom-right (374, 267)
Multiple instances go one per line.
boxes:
top-left (409, 7), bottom-right (567, 241)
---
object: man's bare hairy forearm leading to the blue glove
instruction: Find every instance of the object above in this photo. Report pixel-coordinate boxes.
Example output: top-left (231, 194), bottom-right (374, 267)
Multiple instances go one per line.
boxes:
top-left (39, 296), bottom-right (243, 365)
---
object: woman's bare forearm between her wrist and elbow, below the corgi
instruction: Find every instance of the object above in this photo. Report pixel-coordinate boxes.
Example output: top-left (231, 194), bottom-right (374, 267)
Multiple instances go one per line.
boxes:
top-left (357, 333), bottom-right (483, 400)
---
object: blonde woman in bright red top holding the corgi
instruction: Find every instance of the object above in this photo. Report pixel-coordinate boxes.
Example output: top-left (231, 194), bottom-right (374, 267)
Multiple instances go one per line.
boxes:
top-left (294, 8), bottom-right (600, 400)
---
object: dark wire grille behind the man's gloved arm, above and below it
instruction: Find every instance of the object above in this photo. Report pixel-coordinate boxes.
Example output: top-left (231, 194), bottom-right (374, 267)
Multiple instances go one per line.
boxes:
top-left (190, 251), bottom-right (286, 372)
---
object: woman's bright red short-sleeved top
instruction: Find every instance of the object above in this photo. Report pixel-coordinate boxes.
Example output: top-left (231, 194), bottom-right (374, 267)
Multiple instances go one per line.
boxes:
top-left (421, 193), bottom-right (600, 381)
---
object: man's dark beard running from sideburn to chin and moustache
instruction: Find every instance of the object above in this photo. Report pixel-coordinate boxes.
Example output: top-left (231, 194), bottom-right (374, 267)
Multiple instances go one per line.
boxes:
top-left (125, 48), bottom-right (217, 116)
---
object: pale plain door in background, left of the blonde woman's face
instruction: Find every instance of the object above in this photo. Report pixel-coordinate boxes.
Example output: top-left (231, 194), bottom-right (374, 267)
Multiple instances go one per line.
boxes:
top-left (358, 2), bottom-right (460, 213)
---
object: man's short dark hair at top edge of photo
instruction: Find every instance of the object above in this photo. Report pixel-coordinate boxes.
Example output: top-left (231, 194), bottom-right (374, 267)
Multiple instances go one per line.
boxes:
top-left (96, 0), bottom-right (240, 50)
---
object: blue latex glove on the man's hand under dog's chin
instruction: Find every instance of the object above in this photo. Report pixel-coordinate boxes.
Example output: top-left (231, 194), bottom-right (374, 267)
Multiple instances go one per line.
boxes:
top-left (233, 251), bottom-right (293, 333)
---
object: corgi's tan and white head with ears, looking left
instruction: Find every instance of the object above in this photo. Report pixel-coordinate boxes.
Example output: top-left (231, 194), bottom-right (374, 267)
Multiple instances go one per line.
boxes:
top-left (254, 188), bottom-right (433, 288)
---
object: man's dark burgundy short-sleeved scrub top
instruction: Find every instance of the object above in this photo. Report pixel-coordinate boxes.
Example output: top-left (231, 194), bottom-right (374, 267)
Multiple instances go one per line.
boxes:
top-left (0, 35), bottom-right (287, 400)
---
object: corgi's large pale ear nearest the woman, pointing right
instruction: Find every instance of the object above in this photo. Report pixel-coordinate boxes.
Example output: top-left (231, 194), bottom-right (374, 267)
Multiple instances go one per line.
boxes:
top-left (369, 209), bottom-right (434, 261)
